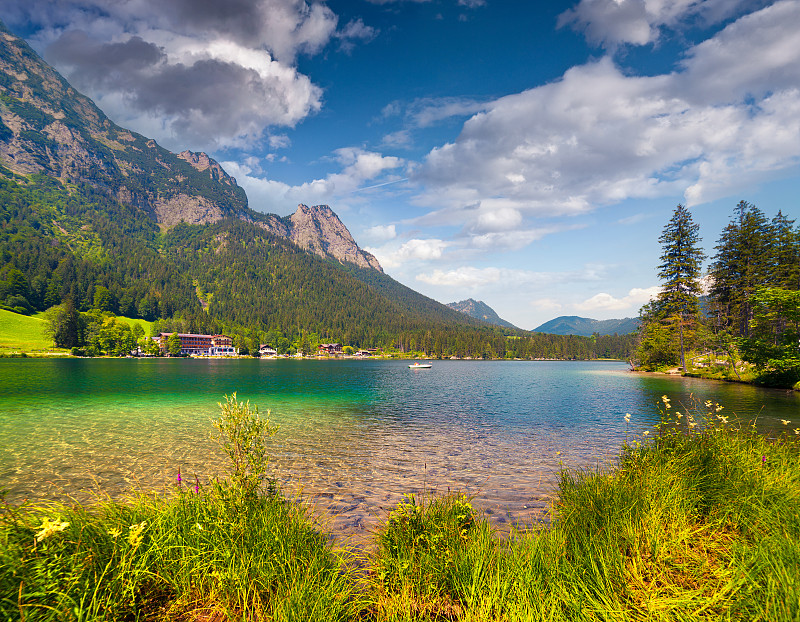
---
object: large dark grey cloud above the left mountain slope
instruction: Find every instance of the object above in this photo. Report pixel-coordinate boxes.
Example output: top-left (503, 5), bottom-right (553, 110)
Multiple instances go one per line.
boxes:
top-left (4, 0), bottom-right (376, 149)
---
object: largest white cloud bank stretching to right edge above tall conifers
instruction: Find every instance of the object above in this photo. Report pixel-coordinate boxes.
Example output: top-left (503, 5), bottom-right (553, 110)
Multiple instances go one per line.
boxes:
top-left (412, 0), bottom-right (800, 227)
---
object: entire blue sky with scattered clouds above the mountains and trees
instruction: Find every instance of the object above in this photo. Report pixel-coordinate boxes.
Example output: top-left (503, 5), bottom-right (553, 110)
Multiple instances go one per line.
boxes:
top-left (0, 0), bottom-right (800, 329)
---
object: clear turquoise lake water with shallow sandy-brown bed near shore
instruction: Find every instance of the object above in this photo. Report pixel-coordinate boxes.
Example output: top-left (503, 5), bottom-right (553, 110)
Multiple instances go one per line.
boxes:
top-left (0, 359), bottom-right (800, 535)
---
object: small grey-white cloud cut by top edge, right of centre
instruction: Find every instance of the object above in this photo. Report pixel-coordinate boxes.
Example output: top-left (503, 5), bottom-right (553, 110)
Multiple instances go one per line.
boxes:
top-left (558, 0), bottom-right (767, 48)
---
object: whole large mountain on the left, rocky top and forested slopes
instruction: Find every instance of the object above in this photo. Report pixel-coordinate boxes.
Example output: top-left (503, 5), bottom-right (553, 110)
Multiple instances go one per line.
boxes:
top-left (0, 24), bottom-right (629, 359)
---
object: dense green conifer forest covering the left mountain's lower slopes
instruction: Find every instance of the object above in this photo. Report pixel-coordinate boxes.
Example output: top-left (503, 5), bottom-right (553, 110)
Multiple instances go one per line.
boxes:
top-left (0, 170), bottom-right (633, 359)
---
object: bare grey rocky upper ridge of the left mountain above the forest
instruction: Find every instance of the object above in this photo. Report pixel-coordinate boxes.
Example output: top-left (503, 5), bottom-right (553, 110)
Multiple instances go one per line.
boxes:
top-left (0, 23), bottom-right (382, 271)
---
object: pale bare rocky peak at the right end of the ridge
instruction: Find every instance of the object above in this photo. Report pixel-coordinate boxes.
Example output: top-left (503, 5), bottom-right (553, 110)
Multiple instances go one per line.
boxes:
top-left (288, 204), bottom-right (383, 272)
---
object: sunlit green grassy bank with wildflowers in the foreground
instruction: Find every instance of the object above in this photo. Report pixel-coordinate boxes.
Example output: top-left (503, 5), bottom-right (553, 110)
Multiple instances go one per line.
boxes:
top-left (0, 400), bottom-right (800, 622)
